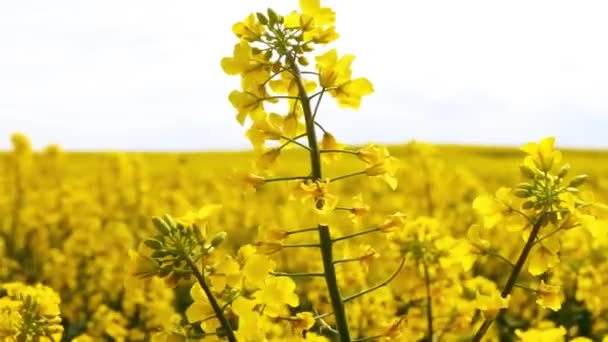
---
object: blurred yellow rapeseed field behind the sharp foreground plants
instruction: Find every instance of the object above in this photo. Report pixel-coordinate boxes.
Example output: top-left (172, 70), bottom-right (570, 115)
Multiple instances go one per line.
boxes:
top-left (0, 137), bottom-right (608, 341)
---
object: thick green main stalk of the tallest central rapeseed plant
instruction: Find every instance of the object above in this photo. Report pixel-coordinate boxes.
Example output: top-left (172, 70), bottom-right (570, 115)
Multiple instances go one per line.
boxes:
top-left (289, 58), bottom-right (351, 342)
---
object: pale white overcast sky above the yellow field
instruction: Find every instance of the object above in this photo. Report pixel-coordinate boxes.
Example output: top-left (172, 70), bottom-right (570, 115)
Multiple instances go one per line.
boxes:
top-left (0, 0), bottom-right (608, 150)
